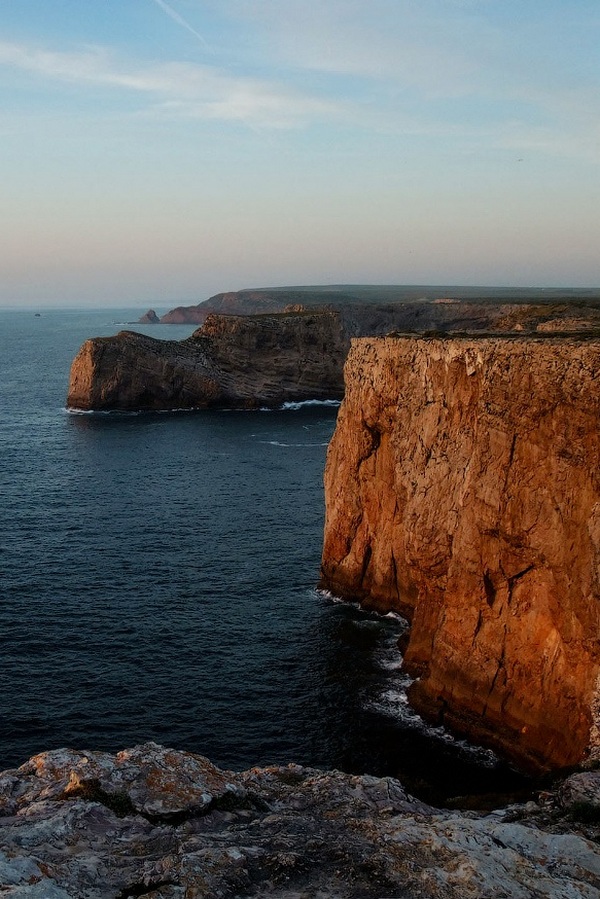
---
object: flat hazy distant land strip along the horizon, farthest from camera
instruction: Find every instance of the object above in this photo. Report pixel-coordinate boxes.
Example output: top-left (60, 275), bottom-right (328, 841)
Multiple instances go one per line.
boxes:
top-left (141, 284), bottom-right (600, 325)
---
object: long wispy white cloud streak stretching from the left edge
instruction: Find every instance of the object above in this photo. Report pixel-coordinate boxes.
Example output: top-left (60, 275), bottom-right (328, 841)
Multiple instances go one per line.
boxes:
top-left (0, 42), bottom-right (341, 128)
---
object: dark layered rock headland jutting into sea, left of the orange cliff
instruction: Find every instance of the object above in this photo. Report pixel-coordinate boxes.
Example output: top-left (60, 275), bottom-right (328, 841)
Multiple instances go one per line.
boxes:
top-left (67, 312), bottom-right (349, 410)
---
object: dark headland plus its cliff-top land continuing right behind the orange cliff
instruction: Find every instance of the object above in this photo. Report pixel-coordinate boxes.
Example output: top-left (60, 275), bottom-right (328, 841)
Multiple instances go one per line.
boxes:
top-left (67, 302), bottom-right (600, 410)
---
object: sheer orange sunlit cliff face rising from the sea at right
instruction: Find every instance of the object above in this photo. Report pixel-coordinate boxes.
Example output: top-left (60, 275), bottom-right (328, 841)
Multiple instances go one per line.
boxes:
top-left (322, 335), bottom-right (600, 770)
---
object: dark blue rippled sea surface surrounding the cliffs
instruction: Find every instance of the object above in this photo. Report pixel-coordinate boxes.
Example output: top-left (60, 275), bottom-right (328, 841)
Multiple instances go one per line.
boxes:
top-left (0, 309), bottom-right (527, 803)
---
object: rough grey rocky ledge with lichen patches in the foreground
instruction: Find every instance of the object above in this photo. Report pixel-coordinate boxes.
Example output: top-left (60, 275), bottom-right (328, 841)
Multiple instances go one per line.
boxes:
top-left (0, 743), bottom-right (600, 899)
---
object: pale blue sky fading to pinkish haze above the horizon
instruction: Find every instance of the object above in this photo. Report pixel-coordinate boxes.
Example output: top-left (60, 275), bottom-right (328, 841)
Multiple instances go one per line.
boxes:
top-left (0, 0), bottom-right (600, 308)
